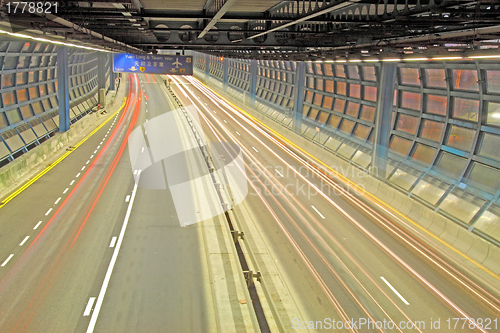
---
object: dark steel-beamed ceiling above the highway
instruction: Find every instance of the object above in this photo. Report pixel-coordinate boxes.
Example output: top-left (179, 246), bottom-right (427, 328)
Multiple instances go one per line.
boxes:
top-left (0, 0), bottom-right (500, 60)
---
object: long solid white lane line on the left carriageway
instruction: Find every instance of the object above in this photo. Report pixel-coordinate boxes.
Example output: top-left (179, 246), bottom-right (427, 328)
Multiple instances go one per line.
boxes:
top-left (87, 172), bottom-right (141, 333)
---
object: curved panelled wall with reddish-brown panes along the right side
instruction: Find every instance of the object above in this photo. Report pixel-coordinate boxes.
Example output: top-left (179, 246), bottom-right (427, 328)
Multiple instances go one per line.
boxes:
top-left (194, 53), bottom-right (500, 242)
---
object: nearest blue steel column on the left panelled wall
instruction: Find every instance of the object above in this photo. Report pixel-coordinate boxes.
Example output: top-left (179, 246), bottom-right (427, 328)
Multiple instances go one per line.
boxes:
top-left (57, 45), bottom-right (70, 132)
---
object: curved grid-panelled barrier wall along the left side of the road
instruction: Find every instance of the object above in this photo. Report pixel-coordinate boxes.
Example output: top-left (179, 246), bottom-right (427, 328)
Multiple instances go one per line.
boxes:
top-left (0, 41), bottom-right (112, 166)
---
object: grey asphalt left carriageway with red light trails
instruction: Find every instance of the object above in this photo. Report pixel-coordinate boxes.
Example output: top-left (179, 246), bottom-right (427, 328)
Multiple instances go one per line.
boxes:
top-left (0, 75), bottom-right (215, 333)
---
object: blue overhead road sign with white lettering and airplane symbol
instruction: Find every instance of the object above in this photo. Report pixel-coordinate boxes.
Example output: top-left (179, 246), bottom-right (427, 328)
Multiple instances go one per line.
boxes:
top-left (113, 53), bottom-right (193, 75)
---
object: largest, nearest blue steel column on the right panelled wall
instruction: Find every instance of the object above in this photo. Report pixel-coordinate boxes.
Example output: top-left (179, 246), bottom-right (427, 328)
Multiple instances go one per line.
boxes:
top-left (371, 62), bottom-right (398, 180)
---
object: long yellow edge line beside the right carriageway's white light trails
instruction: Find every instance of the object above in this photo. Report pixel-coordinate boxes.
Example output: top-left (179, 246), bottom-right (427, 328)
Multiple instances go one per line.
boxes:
top-left (198, 80), bottom-right (500, 280)
